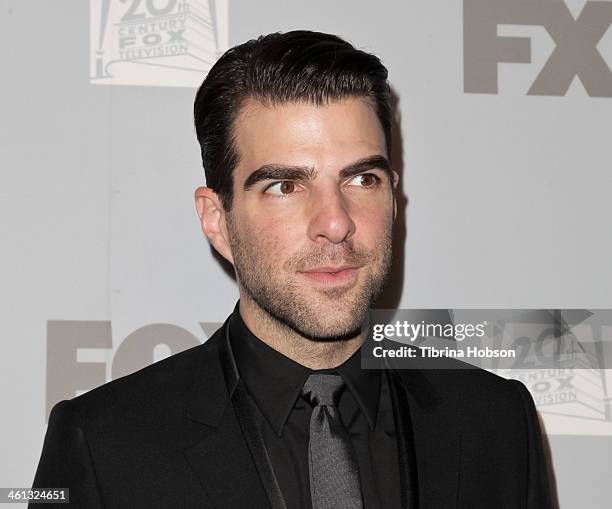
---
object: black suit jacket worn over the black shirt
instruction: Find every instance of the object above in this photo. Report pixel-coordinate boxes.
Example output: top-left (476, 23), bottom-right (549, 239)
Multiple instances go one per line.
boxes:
top-left (32, 312), bottom-right (551, 509)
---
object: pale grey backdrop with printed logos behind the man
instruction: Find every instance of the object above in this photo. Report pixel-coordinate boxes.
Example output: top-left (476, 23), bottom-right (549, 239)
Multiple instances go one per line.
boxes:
top-left (0, 0), bottom-right (612, 509)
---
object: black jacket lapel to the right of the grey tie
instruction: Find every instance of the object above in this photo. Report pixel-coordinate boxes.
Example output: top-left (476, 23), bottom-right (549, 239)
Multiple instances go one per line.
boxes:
top-left (392, 369), bottom-right (461, 509)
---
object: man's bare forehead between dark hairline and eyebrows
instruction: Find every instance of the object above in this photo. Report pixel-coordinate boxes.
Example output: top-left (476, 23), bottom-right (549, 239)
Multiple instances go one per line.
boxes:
top-left (234, 98), bottom-right (387, 174)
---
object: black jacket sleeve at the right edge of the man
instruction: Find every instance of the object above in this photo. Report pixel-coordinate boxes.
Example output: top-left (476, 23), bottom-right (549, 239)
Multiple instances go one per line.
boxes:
top-left (511, 380), bottom-right (553, 509)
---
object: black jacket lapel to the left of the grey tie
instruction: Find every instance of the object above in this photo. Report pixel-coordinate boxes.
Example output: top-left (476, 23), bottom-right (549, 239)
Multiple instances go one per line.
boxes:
top-left (184, 320), bottom-right (271, 509)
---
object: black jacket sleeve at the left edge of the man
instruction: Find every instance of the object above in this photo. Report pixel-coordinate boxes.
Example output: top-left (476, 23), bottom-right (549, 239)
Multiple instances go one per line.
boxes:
top-left (28, 401), bottom-right (103, 509)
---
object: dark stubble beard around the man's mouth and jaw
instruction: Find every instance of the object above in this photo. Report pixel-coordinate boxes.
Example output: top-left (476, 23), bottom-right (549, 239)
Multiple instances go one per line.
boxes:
top-left (227, 212), bottom-right (392, 342)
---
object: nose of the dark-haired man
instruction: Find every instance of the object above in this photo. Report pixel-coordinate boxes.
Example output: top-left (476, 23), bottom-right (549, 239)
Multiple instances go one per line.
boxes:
top-left (308, 188), bottom-right (355, 243)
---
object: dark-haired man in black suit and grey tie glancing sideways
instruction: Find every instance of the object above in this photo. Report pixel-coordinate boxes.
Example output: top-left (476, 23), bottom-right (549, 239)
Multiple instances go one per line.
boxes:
top-left (34, 31), bottom-right (550, 509)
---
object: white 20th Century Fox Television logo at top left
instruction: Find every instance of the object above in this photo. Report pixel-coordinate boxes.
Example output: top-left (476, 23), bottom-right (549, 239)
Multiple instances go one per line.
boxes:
top-left (90, 0), bottom-right (228, 87)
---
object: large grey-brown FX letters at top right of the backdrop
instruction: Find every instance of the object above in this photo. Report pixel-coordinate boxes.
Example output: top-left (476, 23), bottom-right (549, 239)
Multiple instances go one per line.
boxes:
top-left (463, 0), bottom-right (612, 97)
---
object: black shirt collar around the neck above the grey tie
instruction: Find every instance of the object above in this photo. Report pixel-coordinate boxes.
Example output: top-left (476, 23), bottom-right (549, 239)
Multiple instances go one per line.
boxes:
top-left (229, 300), bottom-right (381, 436)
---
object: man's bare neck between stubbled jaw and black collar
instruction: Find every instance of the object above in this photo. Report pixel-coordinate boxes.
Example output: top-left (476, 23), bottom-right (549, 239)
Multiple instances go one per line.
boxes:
top-left (239, 295), bottom-right (365, 369)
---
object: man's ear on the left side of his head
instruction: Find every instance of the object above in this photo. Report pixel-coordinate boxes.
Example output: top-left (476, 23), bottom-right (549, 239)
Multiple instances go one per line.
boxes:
top-left (195, 187), bottom-right (234, 265)
